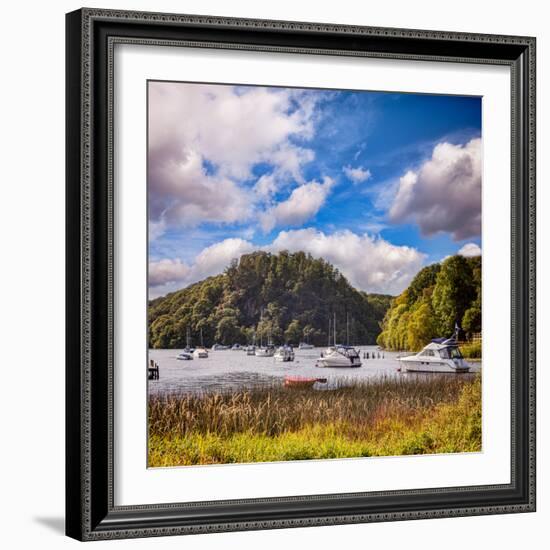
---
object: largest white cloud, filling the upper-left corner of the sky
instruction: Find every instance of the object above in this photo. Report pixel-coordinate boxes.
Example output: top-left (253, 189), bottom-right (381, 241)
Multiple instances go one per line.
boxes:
top-left (148, 82), bottom-right (316, 237)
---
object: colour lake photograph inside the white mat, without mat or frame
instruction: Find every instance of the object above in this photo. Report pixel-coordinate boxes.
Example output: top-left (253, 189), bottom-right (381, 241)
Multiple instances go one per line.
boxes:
top-left (149, 80), bottom-right (484, 468)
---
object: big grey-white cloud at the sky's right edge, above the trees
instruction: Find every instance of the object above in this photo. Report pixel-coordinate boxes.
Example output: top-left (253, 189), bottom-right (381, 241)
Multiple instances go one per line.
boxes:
top-left (389, 138), bottom-right (482, 240)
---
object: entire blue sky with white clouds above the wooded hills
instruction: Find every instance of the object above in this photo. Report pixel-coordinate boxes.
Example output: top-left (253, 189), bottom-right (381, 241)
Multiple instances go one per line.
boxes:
top-left (148, 82), bottom-right (481, 296)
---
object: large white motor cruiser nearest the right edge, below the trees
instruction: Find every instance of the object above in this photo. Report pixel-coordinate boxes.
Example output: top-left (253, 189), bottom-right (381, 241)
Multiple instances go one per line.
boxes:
top-left (397, 327), bottom-right (470, 373)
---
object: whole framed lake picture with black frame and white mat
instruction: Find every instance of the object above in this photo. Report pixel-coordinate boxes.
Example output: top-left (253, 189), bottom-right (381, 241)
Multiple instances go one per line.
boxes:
top-left (66, 9), bottom-right (535, 540)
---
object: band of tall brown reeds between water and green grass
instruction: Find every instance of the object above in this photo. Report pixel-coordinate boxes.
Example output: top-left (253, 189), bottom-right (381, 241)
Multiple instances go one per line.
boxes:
top-left (149, 375), bottom-right (470, 436)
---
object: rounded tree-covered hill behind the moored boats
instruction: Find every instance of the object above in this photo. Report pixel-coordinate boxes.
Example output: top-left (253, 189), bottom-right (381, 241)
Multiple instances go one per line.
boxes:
top-left (149, 252), bottom-right (392, 348)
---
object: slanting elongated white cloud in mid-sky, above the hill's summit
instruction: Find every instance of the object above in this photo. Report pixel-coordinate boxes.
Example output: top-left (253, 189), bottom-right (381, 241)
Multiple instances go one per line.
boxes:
top-left (260, 177), bottom-right (334, 232)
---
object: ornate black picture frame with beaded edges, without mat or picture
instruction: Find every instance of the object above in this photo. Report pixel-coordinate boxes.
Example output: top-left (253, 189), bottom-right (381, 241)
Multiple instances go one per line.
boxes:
top-left (66, 9), bottom-right (535, 540)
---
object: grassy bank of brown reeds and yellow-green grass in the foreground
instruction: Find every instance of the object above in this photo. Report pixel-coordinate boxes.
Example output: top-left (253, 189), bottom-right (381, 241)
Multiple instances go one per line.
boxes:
top-left (149, 376), bottom-right (481, 466)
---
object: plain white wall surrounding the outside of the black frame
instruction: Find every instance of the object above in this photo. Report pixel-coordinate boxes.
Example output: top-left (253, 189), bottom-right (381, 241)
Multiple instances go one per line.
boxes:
top-left (0, 0), bottom-right (550, 550)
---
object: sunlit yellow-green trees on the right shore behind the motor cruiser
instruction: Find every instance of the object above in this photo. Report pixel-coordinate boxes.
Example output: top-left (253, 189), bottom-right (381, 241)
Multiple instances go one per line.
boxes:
top-left (377, 256), bottom-right (481, 351)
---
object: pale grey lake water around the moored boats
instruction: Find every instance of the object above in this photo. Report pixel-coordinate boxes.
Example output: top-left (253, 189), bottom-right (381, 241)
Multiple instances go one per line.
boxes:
top-left (149, 346), bottom-right (480, 394)
